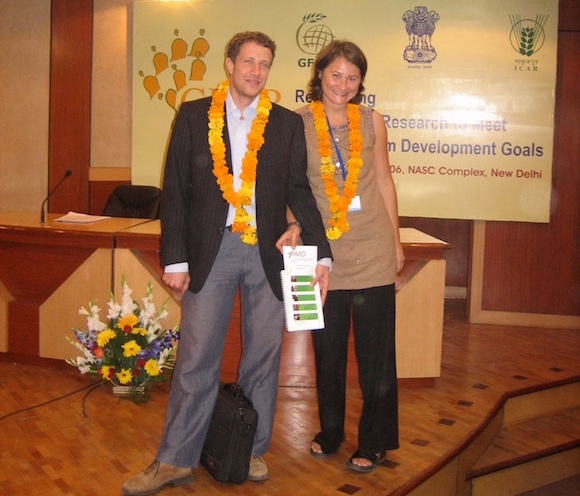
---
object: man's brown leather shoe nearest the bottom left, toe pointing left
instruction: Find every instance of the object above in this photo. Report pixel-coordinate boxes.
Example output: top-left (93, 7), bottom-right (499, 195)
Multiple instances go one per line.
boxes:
top-left (121, 460), bottom-right (193, 496)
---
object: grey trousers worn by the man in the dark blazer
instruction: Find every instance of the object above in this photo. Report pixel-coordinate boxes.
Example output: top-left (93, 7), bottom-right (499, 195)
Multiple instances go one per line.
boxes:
top-left (157, 231), bottom-right (284, 468)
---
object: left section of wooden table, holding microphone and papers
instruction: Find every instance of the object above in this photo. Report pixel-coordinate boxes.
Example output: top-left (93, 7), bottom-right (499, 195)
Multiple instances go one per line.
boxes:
top-left (0, 212), bottom-right (148, 358)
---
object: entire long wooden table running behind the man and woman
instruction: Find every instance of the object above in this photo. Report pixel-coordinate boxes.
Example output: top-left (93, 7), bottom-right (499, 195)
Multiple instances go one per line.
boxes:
top-left (0, 212), bottom-right (450, 387)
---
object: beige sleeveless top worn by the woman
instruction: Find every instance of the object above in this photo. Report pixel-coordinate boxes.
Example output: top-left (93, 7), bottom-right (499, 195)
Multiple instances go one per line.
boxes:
top-left (297, 105), bottom-right (397, 290)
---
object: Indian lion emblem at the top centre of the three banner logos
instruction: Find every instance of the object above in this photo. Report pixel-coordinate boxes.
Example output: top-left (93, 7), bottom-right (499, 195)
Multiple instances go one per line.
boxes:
top-left (402, 6), bottom-right (439, 64)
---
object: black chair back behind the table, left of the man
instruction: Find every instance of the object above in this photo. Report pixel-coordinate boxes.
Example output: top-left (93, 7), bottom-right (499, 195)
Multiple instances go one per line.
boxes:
top-left (102, 185), bottom-right (161, 219)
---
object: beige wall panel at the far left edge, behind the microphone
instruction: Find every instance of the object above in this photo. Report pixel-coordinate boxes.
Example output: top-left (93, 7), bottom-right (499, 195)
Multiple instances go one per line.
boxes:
top-left (0, 0), bottom-right (50, 212)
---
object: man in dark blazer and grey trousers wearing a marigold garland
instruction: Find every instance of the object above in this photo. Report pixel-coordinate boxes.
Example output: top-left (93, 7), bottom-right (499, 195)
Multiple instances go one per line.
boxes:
top-left (123, 32), bottom-right (331, 496)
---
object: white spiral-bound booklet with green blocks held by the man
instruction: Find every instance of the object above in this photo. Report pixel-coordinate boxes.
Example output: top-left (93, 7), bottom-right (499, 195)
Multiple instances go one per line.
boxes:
top-left (280, 246), bottom-right (324, 332)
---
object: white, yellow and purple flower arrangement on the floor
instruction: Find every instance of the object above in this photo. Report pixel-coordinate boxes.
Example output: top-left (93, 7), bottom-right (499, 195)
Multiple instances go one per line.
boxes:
top-left (66, 276), bottom-right (179, 393)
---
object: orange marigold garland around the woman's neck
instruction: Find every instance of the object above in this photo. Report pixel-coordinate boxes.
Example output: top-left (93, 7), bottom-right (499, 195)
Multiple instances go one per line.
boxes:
top-left (310, 101), bottom-right (363, 240)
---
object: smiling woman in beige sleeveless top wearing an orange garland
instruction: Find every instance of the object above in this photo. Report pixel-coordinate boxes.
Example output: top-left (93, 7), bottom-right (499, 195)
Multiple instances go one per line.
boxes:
top-left (289, 40), bottom-right (404, 472)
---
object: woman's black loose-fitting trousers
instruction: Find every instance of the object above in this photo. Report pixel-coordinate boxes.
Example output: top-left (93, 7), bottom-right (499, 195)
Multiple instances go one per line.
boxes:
top-left (312, 284), bottom-right (399, 453)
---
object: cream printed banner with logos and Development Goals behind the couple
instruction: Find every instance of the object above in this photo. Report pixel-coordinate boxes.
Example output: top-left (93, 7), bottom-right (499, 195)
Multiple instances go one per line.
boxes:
top-left (132, 0), bottom-right (558, 222)
